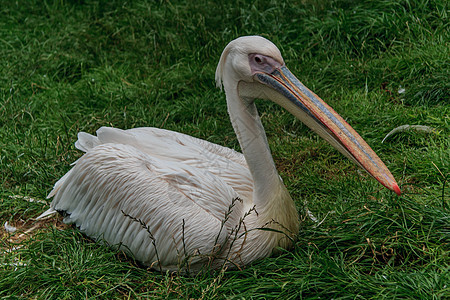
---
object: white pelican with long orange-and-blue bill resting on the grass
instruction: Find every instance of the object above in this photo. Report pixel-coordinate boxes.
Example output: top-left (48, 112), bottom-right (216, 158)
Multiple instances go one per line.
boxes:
top-left (42, 36), bottom-right (400, 271)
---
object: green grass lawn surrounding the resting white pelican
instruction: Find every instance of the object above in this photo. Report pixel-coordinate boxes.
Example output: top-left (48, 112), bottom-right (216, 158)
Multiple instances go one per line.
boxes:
top-left (0, 0), bottom-right (450, 299)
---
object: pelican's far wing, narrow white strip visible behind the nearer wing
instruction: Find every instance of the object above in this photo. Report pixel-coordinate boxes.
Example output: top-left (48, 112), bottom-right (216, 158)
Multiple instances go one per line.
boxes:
top-left (75, 127), bottom-right (253, 199)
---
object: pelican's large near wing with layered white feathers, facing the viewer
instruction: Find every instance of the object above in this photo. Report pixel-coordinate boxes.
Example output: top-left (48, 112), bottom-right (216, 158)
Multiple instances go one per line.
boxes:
top-left (49, 143), bottom-right (243, 269)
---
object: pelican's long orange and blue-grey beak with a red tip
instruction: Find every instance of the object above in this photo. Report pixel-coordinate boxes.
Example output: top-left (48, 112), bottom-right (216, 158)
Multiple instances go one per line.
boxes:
top-left (254, 66), bottom-right (401, 195)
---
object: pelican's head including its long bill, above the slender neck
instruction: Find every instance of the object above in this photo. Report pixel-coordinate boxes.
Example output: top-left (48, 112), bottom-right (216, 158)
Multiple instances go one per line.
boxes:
top-left (216, 36), bottom-right (401, 195)
